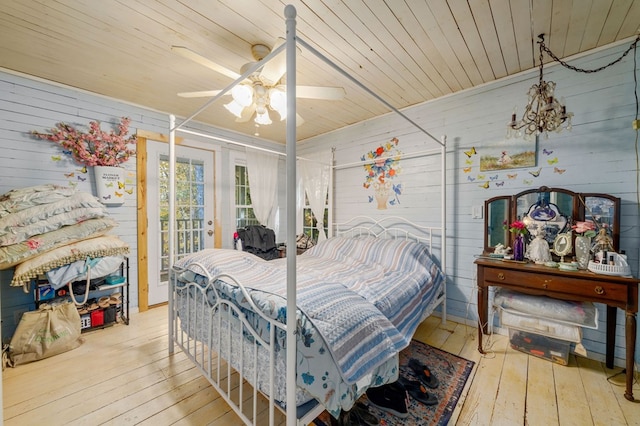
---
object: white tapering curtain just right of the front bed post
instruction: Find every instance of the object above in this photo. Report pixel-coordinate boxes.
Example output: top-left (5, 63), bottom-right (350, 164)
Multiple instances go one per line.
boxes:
top-left (298, 152), bottom-right (331, 241)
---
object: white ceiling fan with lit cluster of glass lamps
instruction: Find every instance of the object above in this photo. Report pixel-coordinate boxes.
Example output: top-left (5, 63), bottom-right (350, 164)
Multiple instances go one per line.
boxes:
top-left (171, 38), bottom-right (345, 126)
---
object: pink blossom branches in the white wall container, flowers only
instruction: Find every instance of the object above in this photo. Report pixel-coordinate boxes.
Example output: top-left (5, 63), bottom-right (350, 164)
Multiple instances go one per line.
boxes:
top-left (31, 117), bottom-right (136, 166)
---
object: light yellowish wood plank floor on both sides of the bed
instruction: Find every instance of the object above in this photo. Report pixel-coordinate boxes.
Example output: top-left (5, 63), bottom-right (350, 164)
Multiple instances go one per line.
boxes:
top-left (3, 307), bottom-right (640, 426)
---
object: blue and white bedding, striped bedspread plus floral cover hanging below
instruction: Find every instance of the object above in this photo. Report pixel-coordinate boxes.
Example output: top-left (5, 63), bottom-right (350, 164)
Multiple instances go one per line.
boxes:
top-left (175, 237), bottom-right (443, 415)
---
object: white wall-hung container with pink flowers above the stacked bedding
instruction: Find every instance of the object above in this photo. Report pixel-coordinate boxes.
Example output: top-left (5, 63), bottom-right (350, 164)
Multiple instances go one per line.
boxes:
top-left (32, 117), bottom-right (136, 204)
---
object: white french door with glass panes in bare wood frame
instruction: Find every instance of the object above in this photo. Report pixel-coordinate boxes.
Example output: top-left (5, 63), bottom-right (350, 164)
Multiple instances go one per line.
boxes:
top-left (147, 141), bottom-right (215, 306)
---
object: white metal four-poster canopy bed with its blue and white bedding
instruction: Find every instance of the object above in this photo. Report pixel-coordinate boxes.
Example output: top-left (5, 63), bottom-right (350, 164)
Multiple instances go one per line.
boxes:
top-left (169, 5), bottom-right (446, 425)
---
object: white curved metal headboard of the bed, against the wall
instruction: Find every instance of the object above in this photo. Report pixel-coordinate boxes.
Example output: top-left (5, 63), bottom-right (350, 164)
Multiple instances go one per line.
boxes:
top-left (334, 216), bottom-right (442, 249)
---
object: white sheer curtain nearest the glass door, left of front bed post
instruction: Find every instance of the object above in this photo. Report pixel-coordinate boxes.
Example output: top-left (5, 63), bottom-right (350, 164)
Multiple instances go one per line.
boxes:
top-left (246, 148), bottom-right (278, 229)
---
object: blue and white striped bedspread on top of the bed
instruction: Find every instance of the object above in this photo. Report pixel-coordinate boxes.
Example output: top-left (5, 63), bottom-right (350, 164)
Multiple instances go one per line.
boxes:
top-left (176, 237), bottom-right (443, 383)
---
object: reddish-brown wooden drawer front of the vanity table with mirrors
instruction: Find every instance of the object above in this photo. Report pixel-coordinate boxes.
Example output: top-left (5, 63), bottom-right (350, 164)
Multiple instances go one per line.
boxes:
top-left (483, 267), bottom-right (627, 303)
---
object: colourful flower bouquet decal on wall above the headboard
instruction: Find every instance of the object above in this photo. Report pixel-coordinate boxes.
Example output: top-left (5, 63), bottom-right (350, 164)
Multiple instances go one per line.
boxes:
top-left (360, 137), bottom-right (402, 210)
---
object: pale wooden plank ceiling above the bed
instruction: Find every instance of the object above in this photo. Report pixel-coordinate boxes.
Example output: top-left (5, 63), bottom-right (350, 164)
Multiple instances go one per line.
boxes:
top-left (0, 0), bottom-right (640, 142)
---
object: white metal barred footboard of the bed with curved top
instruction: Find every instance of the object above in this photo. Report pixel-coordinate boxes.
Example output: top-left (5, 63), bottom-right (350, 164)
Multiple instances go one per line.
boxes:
top-left (169, 264), bottom-right (285, 425)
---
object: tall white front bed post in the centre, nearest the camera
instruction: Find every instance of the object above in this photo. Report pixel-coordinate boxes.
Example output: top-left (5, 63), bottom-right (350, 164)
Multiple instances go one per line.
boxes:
top-left (284, 4), bottom-right (297, 426)
